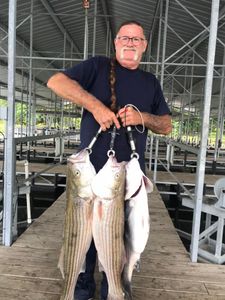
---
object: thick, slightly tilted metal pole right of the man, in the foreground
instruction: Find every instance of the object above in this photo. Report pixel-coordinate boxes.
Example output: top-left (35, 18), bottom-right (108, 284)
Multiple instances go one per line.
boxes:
top-left (190, 0), bottom-right (220, 262)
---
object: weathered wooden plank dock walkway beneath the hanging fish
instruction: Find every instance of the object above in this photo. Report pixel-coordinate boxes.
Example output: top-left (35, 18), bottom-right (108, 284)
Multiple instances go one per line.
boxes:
top-left (0, 175), bottom-right (225, 300)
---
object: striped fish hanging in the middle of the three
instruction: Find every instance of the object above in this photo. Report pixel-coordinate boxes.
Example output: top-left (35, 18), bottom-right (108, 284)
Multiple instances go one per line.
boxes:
top-left (92, 156), bottom-right (125, 300)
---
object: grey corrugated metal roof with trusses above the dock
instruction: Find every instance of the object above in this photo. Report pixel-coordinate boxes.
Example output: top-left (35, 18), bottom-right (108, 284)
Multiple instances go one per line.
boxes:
top-left (0, 0), bottom-right (225, 114)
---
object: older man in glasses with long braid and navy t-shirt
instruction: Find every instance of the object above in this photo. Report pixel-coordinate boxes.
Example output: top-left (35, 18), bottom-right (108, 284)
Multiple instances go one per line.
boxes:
top-left (48, 21), bottom-right (172, 300)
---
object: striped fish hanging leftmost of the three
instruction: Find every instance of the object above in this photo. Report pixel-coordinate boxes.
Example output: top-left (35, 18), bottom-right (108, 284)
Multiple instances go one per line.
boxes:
top-left (58, 150), bottom-right (96, 300)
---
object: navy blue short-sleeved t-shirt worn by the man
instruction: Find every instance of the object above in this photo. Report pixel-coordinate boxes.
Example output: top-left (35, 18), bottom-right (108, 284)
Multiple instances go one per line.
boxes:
top-left (64, 56), bottom-right (170, 172)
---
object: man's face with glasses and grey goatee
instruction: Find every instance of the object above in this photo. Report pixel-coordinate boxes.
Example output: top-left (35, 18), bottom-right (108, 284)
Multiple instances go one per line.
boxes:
top-left (114, 24), bottom-right (147, 69)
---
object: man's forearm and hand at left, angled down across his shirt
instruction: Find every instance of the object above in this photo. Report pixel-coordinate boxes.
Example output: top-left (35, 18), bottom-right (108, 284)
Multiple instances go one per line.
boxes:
top-left (47, 73), bottom-right (120, 130)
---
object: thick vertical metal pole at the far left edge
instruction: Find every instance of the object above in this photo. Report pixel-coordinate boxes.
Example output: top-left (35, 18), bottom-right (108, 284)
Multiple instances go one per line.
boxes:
top-left (3, 0), bottom-right (17, 246)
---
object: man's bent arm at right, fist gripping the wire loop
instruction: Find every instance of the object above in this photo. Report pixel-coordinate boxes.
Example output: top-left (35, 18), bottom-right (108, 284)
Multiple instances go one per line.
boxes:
top-left (119, 107), bottom-right (172, 135)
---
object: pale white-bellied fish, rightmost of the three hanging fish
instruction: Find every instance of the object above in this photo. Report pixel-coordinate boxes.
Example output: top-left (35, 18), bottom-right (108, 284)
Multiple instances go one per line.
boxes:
top-left (122, 157), bottom-right (153, 300)
